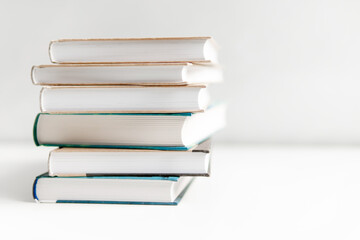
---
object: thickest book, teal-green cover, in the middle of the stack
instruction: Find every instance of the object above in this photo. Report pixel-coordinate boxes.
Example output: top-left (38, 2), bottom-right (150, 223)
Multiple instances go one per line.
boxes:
top-left (33, 104), bottom-right (225, 150)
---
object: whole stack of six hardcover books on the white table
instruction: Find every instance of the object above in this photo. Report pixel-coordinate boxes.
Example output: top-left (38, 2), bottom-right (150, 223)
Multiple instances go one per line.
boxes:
top-left (32, 37), bottom-right (225, 205)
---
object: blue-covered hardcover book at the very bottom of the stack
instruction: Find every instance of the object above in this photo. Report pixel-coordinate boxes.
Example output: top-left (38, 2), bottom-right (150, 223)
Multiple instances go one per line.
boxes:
top-left (33, 174), bottom-right (193, 205)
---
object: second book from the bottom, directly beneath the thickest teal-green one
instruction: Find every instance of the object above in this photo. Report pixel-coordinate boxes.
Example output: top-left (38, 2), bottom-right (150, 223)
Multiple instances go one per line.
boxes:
top-left (48, 140), bottom-right (210, 177)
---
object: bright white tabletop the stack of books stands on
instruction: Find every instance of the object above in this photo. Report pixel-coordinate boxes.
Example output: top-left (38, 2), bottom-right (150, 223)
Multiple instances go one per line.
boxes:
top-left (0, 143), bottom-right (360, 240)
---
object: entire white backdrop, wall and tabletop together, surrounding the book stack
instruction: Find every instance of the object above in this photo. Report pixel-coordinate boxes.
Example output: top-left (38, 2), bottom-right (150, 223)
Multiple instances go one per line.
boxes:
top-left (0, 0), bottom-right (360, 240)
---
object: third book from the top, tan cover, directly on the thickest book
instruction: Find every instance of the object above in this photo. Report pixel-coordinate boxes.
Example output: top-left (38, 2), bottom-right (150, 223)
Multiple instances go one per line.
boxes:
top-left (40, 86), bottom-right (210, 113)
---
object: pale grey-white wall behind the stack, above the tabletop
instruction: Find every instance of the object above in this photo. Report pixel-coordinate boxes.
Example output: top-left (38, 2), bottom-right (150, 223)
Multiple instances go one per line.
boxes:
top-left (0, 0), bottom-right (360, 143)
